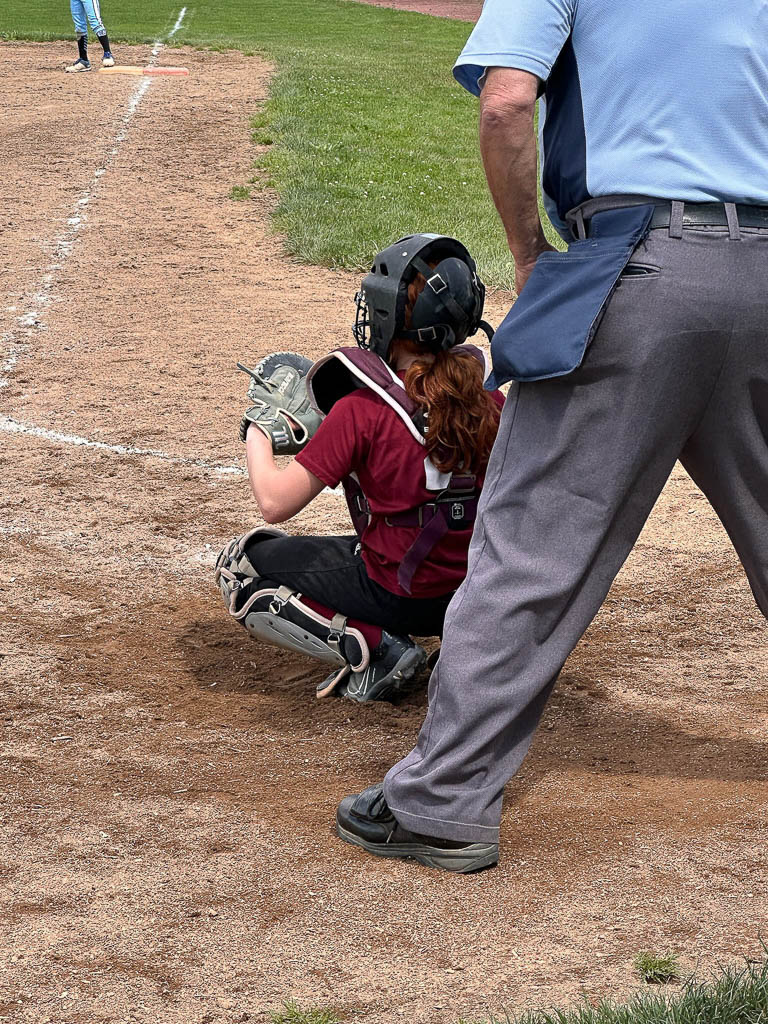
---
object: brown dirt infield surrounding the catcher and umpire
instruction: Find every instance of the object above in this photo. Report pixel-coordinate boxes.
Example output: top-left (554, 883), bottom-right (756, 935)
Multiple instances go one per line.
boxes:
top-left (0, 37), bottom-right (768, 1024)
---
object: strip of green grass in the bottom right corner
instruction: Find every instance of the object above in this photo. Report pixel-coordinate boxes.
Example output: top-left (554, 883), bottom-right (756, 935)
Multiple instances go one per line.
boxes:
top-left (459, 957), bottom-right (768, 1024)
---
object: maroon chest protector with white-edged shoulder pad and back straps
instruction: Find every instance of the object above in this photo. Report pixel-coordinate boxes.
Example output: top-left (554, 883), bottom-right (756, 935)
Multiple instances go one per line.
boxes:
top-left (306, 345), bottom-right (485, 595)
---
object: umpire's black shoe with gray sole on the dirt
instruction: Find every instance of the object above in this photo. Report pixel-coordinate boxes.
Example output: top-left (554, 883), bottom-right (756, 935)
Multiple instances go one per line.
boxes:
top-left (336, 782), bottom-right (499, 874)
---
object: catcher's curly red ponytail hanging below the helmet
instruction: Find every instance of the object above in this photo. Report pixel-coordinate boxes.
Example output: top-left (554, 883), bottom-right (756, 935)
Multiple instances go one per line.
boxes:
top-left (389, 272), bottom-right (501, 473)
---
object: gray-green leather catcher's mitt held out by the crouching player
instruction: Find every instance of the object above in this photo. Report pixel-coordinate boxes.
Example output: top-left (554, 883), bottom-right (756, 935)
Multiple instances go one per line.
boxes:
top-left (238, 352), bottom-right (322, 455)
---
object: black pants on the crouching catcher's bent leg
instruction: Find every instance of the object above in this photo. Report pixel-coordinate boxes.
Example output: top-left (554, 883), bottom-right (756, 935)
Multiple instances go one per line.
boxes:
top-left (246, 537), bottom-right (453, 637)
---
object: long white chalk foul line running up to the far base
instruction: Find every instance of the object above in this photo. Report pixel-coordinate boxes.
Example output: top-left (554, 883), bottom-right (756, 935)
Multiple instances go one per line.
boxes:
top-left (0, 7), bottom-right (186, 388)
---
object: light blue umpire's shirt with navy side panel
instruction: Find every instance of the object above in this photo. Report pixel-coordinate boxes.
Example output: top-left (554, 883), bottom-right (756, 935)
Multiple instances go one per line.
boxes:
top-left (454, 0), bottom-right (768, 232)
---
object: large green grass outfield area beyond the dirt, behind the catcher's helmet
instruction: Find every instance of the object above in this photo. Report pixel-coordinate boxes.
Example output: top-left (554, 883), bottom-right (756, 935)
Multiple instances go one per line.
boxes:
top-left (0, 0), bottom-right (565, 288)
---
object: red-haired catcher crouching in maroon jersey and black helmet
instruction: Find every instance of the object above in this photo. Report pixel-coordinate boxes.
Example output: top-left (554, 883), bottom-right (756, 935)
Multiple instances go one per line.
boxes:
top-left (216, 234), bottom-right (503, 701)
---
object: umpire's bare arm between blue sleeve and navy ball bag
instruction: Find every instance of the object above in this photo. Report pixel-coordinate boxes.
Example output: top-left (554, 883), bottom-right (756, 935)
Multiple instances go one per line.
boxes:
top-left (480, 68), bottom-right (551, 284)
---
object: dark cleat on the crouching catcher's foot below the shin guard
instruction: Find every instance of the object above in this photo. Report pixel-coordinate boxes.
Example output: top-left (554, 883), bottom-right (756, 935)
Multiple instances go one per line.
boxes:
top-left (317, 631), bottom-right (427, 703)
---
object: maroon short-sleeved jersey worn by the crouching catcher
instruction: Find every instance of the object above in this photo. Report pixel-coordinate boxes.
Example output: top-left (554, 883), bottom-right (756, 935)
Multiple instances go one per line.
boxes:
top-left (296, 374), bottom-right (504, 597)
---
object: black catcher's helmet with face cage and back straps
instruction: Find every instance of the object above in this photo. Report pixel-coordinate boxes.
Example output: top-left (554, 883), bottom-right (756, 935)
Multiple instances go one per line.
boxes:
top-left (354, 234), bottom-right (493, 358)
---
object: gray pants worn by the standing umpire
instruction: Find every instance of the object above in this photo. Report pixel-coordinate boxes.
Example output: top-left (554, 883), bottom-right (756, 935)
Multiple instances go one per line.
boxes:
top-left (385, 227), bottom-right (768, 842)
